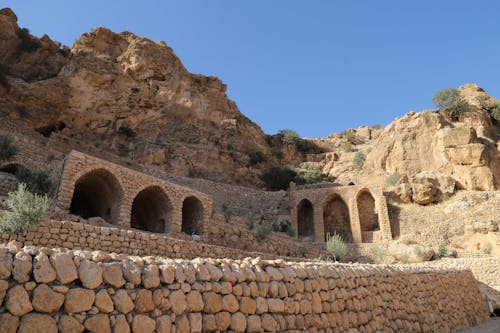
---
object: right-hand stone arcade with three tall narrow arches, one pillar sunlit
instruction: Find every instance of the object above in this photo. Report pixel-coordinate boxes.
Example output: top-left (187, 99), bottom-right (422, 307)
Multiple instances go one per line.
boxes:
top-left (290, 186), bottom-right (392, 243)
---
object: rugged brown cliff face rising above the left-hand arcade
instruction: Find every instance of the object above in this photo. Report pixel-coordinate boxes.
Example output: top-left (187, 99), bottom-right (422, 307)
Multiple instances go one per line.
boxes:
top-left (0, 9), bottom-right (274, 185)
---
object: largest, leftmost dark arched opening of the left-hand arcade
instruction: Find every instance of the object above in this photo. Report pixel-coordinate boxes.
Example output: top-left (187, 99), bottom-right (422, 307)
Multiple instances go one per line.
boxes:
top-left (69, 169), bottom-right (123, 224)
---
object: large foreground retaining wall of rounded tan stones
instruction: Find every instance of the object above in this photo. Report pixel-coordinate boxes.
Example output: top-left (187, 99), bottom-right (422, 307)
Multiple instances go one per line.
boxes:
top-left (0, 247), bottom-right (488, 333)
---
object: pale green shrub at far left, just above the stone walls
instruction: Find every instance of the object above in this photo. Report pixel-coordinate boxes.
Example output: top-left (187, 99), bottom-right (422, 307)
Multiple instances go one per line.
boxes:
top-left (0, 183), bottom-right (50, 234)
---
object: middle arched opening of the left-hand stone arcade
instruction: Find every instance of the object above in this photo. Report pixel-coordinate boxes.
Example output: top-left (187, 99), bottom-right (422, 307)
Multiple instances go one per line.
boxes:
top-left (130, 186), bottom-right (172, 233)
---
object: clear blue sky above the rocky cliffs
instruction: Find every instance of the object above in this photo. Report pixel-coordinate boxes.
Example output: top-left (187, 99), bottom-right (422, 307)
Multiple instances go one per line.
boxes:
top-left (2, 0), bottom-right (500, 137)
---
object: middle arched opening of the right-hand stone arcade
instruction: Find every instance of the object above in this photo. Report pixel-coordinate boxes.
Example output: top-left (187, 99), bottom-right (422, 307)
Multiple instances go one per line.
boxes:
top-left (323, 194), bottom-right (352, 243)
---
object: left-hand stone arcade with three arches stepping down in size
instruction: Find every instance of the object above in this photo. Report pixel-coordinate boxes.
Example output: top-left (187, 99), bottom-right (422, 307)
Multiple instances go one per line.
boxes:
top-left (57, 151), bottom-right (212, 234)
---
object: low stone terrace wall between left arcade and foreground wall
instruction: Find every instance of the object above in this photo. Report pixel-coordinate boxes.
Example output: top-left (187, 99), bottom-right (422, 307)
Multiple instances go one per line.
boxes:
top-left (0, 221), bottom-right (316, 259)
